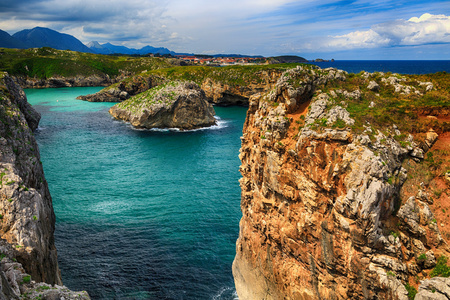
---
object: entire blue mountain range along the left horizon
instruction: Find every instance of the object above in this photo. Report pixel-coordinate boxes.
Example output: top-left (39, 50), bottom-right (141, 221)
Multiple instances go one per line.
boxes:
top-left (0, 27), bottom-right (176, 55)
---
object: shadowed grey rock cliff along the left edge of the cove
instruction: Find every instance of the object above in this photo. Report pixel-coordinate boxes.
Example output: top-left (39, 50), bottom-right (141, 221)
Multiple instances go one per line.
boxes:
top-left (0, 73), bottom-right (87, 299)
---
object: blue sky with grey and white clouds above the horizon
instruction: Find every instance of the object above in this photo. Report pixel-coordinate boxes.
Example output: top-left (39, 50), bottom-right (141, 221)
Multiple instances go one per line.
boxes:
top-left (0, 0), bottom-right (450, 60)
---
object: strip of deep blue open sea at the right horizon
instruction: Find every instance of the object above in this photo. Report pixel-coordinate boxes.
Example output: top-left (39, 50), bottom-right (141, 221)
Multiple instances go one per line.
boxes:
top-left (311, 60), bottom-right (450, 74)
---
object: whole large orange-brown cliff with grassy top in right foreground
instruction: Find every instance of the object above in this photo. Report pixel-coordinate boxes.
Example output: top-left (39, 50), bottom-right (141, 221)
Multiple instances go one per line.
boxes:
top-left (233, 66), bottom-right (450, 300)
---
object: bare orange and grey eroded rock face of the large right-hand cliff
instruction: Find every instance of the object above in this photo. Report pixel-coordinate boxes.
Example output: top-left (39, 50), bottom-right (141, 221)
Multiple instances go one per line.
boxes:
top-left (233, 67), bottom-right (443, 300)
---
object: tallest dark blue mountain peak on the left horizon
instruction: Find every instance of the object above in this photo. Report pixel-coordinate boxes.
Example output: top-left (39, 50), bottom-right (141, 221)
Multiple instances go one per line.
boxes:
top-left (13, 27), bottom-right (93, 53)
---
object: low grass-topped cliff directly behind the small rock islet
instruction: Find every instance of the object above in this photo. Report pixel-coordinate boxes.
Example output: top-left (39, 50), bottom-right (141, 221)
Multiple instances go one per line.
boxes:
top-left (77, 65), bottom-right (288, 106)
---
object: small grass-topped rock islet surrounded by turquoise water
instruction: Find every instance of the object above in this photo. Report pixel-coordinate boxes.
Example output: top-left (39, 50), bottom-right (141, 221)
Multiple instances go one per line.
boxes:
top-left (109, 81), bottom-right (216, 130)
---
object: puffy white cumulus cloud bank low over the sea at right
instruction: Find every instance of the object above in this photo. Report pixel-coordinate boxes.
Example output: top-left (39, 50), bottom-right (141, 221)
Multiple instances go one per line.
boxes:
top-left (322, 13), bottom-right (450, 49)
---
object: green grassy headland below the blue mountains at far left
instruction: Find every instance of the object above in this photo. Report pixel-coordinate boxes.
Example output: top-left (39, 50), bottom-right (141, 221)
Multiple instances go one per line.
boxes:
top-left (0, 47), bottom-right (176, 79)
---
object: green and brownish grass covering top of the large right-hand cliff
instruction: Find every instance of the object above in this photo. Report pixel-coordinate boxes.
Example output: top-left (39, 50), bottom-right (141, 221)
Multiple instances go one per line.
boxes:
top-left (321, 72), bottom-right (450, 135)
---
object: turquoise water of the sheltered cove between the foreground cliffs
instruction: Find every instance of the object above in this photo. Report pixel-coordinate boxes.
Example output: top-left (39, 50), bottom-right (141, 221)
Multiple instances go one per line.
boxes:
top-left (26, 88), bottom-right (246, 299)
